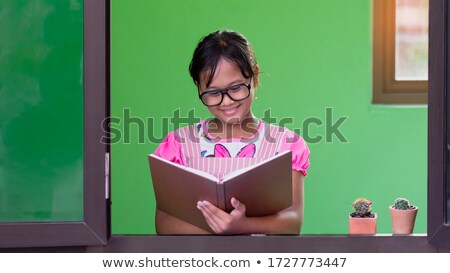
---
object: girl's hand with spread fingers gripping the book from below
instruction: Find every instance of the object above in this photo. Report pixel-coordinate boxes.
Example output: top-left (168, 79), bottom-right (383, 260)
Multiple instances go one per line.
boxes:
top-left (197, 197), bottom-right (247, 234)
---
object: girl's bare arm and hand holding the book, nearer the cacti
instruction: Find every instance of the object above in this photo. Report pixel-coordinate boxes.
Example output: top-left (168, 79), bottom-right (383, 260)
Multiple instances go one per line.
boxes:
top-left (197, 171), bottom-right (304, 234)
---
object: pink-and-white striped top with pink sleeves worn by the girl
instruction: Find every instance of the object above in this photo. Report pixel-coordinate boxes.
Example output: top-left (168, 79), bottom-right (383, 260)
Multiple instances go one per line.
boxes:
top-left (154, 120), bottom-right (310, 179)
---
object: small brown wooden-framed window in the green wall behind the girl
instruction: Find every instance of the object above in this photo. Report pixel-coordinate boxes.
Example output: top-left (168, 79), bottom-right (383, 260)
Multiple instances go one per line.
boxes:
top-left (373, 0), bottom-right (429, 104)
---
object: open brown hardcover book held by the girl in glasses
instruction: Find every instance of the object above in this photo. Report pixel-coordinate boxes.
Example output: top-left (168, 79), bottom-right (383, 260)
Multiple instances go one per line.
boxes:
top-left (148, 151), bottom-right (292, 231)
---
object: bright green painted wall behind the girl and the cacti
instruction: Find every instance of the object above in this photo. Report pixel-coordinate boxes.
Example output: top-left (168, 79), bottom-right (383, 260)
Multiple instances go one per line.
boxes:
top-left (111, 0), bottom-right (427, 234)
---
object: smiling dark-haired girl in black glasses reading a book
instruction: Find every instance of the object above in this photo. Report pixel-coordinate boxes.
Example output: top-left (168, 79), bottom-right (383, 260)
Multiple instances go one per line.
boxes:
top-left (155, 30), bottom-right (310, 234)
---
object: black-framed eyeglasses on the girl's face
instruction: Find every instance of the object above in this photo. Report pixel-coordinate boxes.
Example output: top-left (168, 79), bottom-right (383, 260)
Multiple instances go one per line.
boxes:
top-left (198, 78), bottom-right (252, 107)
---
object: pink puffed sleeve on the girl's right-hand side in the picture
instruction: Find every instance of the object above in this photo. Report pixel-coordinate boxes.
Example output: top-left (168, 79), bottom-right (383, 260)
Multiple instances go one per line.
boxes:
top-left (279, 130), bottom-right (310, 176)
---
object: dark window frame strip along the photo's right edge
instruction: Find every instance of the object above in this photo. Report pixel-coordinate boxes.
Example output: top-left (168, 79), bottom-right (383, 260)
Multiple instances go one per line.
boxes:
top-left (427, 1), bottom-right (450, 248)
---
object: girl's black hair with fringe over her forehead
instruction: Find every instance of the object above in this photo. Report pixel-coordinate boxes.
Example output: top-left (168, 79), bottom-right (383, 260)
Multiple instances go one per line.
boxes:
top-left (189, 30), bottom-right (258, 87)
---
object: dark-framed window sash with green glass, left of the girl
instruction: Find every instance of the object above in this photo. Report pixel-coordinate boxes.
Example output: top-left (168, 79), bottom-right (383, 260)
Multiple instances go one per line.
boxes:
top-left (0, 0), bottom-right (109, 248)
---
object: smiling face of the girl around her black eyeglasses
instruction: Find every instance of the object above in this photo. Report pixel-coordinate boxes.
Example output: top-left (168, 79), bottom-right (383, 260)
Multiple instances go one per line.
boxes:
top-left (199, 59), bottom-right (257, 125)
